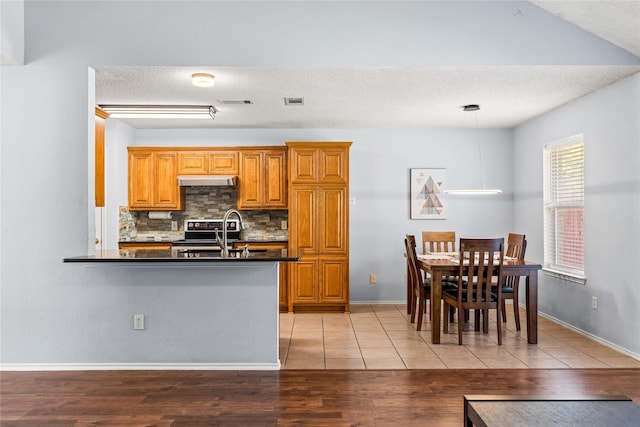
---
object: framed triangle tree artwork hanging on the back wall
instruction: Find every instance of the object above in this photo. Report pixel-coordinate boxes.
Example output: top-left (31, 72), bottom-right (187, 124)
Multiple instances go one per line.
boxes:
top-left (410, 169), bottom-right (447, 219)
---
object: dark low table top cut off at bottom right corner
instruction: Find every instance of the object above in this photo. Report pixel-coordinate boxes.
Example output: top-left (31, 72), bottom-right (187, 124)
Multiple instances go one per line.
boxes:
top-left (464, 395), bottom-right (640, 427)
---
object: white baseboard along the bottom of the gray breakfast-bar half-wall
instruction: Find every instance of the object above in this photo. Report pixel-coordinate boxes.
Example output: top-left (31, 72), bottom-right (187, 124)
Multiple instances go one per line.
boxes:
top-left (0, 362), bottom-right (280, 371)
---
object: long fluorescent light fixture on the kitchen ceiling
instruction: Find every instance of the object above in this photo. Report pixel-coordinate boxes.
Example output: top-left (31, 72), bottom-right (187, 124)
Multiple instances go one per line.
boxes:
top-left (100, 105), bottom-right (217, 120)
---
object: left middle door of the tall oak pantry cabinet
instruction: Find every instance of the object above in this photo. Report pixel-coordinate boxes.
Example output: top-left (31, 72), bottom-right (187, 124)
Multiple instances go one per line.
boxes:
top-left (289, 186), bottom-right (318, 255)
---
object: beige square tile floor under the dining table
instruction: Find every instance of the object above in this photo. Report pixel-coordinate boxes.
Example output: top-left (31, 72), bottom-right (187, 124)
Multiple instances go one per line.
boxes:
top-left (280, 304), bottom-right (640, 369)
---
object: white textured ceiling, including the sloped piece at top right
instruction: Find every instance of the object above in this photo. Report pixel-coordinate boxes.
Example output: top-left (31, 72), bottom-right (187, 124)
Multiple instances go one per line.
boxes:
top-left (96, 0), bottom-right (640, 128)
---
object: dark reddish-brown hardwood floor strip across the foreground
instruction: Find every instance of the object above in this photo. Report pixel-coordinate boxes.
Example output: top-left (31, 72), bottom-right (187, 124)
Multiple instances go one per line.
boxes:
top-left (0, 369), bottom-right (640, 427)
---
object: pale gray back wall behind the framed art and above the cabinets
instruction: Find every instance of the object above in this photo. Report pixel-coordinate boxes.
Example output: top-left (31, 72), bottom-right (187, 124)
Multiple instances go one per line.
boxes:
top-left (136, 128), bottom-right (514, 302)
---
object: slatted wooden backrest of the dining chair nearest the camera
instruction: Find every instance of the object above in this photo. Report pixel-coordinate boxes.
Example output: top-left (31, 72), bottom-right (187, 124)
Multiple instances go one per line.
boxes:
top-left (458, 237), bottom-right (504, 305)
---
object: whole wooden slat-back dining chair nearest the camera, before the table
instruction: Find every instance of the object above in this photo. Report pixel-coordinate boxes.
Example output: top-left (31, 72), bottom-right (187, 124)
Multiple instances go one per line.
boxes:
top-left (442, 238), bottom-right (504, 345)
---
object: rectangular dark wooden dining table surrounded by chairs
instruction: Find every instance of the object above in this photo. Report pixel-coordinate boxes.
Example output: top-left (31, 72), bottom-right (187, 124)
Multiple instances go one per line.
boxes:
top-left (407, 257), bottom-right (542, 344)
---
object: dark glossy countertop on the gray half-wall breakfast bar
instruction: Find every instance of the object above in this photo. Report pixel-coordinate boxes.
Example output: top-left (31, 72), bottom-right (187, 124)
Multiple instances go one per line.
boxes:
top-left (63, 249), bottom-right (300, 264)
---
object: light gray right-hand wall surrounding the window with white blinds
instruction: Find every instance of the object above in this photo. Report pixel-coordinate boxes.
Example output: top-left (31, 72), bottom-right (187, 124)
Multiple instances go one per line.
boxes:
top-left (514, 74), bottom-right (640, 355)
